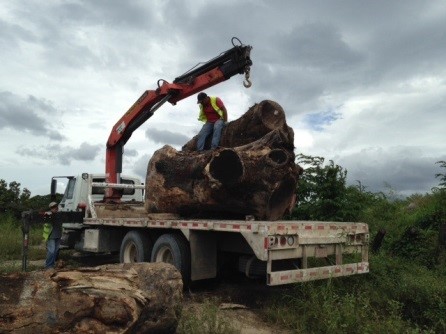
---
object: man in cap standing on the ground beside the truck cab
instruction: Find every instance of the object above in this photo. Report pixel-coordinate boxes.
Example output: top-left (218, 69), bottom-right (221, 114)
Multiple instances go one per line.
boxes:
top-left (43, 202), bottom-right (62, 269)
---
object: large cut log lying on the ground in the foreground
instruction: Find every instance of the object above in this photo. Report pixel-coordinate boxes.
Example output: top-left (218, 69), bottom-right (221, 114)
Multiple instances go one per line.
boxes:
top-left (0, 263), bottom-right (182, 333)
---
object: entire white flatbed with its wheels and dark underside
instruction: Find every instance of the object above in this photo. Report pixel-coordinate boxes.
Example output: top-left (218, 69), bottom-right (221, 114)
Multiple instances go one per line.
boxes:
top-left (65, 200), bottom-right (369, 285)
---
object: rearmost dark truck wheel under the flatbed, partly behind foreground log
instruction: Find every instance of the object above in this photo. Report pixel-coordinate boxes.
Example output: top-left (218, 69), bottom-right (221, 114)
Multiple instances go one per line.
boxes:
top-left (150, 234), bottom-right (190, 287)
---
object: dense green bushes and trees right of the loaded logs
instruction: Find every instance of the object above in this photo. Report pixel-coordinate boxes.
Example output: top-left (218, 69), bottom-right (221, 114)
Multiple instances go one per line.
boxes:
top-left (291, 154), bottom-right (446, 268)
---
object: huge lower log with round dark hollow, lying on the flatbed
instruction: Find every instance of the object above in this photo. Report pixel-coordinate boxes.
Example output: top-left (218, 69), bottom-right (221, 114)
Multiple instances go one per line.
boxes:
top-left (145, 129), bottom-right (301, 220)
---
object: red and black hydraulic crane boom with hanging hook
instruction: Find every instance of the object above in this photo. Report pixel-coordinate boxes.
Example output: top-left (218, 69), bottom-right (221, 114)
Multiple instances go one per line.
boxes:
top-left (104, 37), bottom-right (252, 202)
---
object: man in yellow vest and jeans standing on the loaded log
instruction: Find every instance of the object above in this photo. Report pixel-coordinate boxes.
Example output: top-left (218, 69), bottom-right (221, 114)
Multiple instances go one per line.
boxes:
top-left (197, 92), bottom-right (228, 151)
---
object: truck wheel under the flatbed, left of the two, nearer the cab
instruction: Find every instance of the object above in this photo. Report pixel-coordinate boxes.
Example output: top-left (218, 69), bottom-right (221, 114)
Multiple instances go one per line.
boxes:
top-left (119, 231), bottom-right (152, 263)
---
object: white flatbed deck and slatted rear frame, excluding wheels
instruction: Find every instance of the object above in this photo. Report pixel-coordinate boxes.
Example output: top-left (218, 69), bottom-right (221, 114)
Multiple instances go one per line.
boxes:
top-left (84, 216), bottom-right (369, 285)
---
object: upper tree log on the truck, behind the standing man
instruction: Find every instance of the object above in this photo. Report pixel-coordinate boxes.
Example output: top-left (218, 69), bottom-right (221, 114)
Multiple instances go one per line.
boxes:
top-left (182, 100), bottom-right (294, 152)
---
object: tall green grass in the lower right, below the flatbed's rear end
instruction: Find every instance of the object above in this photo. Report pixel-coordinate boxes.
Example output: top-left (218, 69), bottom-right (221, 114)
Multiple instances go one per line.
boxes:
top-left (263, 255), bottom-right (446, 334)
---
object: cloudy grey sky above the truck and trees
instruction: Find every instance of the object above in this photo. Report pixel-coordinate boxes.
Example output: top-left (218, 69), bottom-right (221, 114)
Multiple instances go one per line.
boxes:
top-left (0, 0), bottom-right (446, 196)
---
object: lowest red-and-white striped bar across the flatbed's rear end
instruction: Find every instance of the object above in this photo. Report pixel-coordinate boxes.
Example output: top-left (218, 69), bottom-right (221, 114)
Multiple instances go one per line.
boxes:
top-left (267, 262), bottom-right (369, 285)
